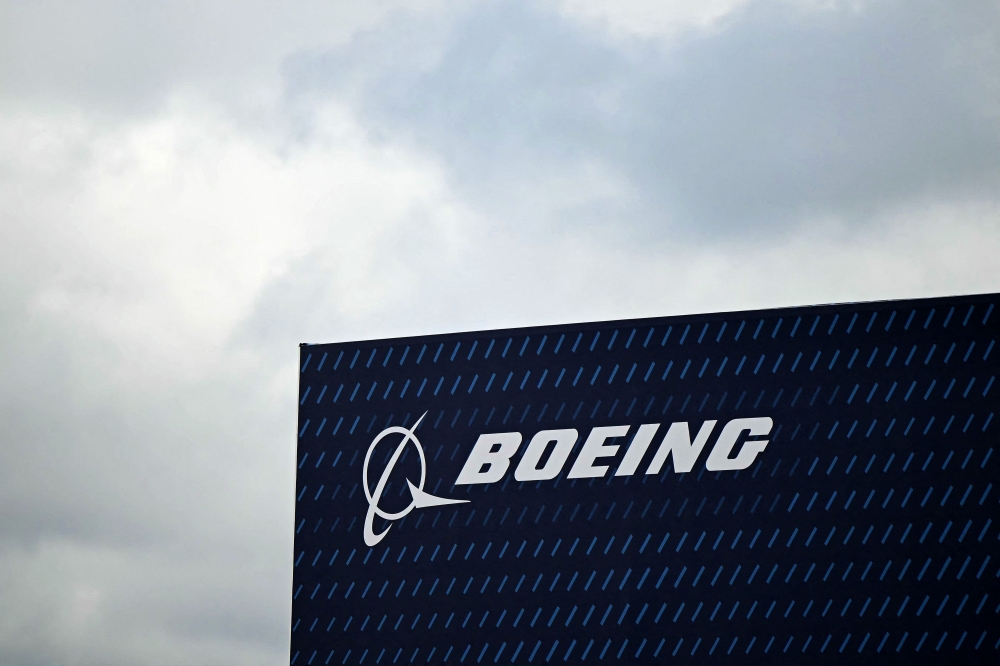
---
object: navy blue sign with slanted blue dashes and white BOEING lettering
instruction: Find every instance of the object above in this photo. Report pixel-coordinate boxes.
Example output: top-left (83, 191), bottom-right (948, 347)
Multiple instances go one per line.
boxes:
top-left (290, 295), bottom-right (1000, 665)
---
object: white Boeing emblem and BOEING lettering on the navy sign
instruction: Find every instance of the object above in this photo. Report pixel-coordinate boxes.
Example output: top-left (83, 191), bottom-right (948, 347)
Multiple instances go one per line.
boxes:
top-left (362, 412), bottom-right (773, 547)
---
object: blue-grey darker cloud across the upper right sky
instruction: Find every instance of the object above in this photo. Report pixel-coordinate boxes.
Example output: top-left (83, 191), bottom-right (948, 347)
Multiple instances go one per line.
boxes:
top-left (292, 2), bottom-right (1000, 236)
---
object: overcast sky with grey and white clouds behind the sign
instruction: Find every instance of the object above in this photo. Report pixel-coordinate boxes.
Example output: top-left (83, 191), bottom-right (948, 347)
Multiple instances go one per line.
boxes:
top-left (0, 0), bottom-right (1000, 666)
